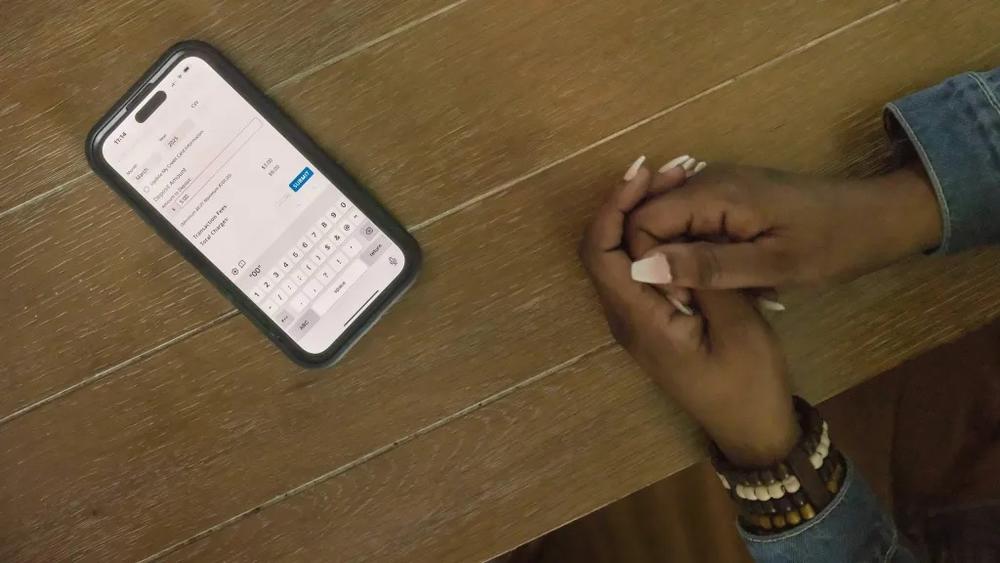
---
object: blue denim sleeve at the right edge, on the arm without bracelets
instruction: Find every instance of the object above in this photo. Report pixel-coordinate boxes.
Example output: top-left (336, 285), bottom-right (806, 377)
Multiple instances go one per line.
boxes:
top-left (885, 69), bottom-right (1000, 253)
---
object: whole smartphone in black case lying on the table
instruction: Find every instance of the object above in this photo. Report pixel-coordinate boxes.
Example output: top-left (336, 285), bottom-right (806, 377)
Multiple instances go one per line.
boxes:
top-left (86, 41), bottom-right (421, 367)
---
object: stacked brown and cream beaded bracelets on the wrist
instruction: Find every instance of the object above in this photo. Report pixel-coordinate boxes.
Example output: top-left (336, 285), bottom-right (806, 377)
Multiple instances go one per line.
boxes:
top-left (712, 397), bottom-right (847, 534)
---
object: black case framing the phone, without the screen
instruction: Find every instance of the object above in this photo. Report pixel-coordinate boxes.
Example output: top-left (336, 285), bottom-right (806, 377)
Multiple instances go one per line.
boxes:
top-left (86, 40), bottom-right (422, 367)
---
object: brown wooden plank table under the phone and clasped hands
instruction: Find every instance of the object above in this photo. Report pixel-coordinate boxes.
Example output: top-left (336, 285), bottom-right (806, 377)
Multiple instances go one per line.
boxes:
top-left (0, 0), bottom-right (1000, 562)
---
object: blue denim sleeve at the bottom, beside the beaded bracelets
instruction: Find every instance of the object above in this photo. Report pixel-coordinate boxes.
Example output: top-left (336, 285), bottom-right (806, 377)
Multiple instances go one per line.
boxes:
top-left (740, 462), bottom-right (916, 563)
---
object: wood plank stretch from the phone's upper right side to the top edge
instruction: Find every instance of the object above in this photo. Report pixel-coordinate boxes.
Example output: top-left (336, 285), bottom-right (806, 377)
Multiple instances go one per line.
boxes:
top-left (276, 0), bottom-right (890, 224)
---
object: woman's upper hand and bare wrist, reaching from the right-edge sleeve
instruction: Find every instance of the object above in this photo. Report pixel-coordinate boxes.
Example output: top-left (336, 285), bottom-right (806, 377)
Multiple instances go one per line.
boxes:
top-left (627, 164), bottom-right (941, 289)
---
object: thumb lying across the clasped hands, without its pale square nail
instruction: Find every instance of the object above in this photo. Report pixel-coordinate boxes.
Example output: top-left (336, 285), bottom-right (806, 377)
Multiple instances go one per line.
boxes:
top-left (645, 242), bottom-right (788, 289)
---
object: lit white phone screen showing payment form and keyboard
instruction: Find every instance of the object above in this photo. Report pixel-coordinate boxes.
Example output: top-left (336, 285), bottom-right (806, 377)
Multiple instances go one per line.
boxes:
top-left (100, 56), bottom-right (405, 354)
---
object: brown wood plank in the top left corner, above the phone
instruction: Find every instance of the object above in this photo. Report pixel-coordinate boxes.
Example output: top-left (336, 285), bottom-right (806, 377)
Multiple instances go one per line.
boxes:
top-left (0, 0), bottom-right (454, 213)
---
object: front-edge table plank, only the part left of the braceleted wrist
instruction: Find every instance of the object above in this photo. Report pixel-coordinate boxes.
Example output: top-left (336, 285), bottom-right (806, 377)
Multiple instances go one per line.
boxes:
top-left (167, 349), bottom-right (700, 563)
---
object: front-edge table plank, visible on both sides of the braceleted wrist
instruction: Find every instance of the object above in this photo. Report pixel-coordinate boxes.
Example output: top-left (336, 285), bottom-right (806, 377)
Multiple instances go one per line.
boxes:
top-left (167, 258), bottom-right (1000, 563)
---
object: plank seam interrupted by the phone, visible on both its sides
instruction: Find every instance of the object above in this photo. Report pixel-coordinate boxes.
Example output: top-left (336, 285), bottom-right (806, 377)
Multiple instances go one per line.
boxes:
top-left (0, 0), bottom-right (910, 427)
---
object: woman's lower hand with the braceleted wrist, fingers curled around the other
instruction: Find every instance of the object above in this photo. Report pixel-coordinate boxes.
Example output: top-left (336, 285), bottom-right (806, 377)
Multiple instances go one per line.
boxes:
top-left (580, 159), bottom-right (800, 467)
